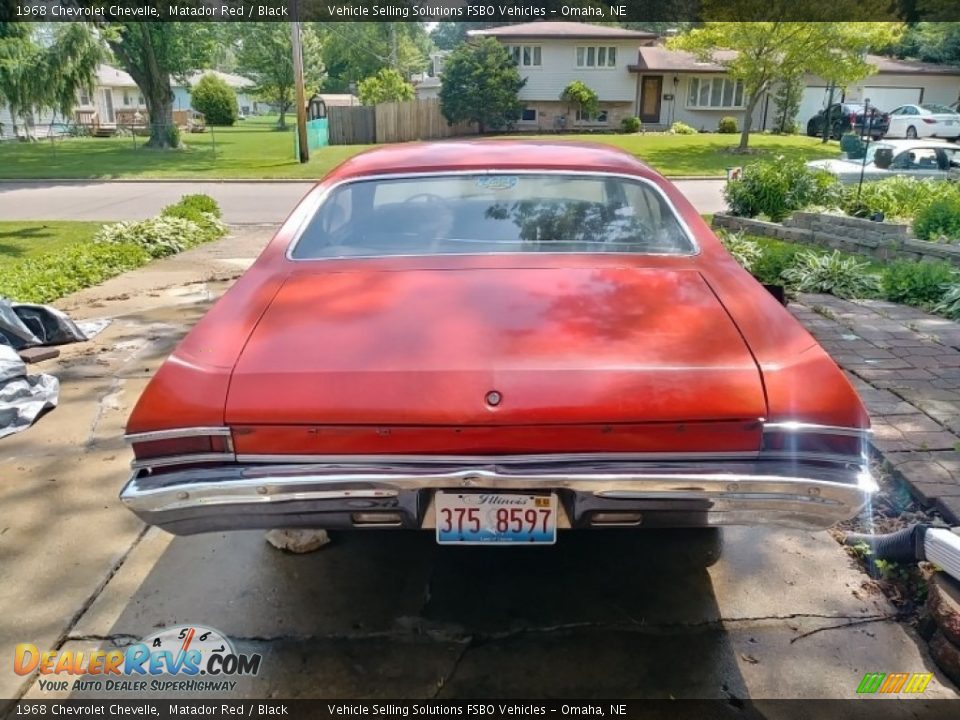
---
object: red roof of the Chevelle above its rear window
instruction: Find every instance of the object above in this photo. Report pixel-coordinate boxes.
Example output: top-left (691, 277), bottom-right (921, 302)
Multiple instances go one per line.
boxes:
top-left (328, 140), bottom-right (659, 180)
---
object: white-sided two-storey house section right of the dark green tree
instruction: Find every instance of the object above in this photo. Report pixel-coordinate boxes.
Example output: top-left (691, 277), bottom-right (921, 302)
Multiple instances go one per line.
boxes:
top-left (469, 21), bottom-right (657, 130)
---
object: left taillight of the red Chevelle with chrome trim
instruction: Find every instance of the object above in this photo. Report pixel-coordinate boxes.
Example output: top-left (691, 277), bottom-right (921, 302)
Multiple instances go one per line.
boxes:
top-left (126, 427), bottom-right (234, 468)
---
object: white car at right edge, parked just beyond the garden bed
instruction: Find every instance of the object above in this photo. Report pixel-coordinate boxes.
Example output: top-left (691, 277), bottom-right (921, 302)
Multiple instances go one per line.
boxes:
top-left (807, 139), bottom-right (960, 183)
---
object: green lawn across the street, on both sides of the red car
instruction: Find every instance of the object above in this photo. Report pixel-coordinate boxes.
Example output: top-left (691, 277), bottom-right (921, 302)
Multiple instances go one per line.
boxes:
top-left (0, 116), bottom-right (839, 180)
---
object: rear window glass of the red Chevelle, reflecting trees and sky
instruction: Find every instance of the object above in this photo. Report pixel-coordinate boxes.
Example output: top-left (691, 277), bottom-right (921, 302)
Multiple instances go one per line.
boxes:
top-left (291, 174), bottom-right (695, 260)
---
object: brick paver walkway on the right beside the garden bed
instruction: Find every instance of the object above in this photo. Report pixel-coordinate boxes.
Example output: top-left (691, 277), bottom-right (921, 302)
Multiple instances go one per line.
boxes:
top-left (790, 294), bottom-right (960, 524)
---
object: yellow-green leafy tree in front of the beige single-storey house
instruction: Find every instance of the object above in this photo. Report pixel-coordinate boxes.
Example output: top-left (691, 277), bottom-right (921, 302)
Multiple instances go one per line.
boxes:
top-left (668, 19), bottom-right (901, 150)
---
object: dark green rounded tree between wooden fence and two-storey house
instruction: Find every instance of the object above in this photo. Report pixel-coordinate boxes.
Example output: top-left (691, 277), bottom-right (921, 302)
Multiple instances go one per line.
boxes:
top-left (440, 37), bottom-right (527, 133)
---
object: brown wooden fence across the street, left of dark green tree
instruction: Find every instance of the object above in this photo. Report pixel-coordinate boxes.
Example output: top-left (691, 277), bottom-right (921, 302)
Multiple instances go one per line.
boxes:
top-left (327, 99), bottom-right (477, 145)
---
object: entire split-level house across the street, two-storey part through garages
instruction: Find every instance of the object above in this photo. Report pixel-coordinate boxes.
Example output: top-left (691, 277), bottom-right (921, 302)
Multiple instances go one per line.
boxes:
top-left (462, 21), bottom-right (960, 131)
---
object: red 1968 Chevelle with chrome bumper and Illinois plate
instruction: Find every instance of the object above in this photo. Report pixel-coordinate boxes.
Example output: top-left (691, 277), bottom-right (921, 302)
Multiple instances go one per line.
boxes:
top-left (121, 141), bottom-right (875, 544)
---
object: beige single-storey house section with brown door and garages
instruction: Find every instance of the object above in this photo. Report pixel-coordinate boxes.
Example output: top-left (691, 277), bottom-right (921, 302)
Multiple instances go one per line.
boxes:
top-left (629, 46), bottom-right (960, 131)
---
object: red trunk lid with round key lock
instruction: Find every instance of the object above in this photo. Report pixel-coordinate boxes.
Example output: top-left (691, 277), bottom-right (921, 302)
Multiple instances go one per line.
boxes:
top-left (226, 267), bottom-right (765, 426)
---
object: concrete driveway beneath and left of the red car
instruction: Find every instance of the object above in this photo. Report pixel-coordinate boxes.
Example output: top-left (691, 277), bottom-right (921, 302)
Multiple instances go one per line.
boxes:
top-left (0, 227), bottom-right (957, 704)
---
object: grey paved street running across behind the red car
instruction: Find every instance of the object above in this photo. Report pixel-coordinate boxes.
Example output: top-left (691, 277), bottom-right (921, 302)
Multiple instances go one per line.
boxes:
top-left (0, 180), bottom-right (725, 224)
